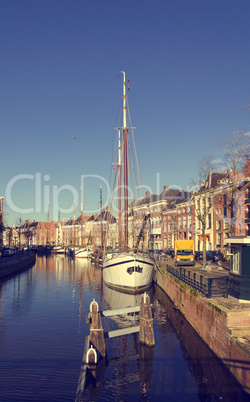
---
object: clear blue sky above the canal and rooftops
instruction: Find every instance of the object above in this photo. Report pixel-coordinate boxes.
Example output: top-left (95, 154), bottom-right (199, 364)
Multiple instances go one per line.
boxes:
top-left (0, 0), bottom-right (250, 225)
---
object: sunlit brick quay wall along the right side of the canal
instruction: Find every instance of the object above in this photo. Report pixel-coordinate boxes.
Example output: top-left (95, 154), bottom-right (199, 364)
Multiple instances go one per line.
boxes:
top-left (154, 268), bottom-right (250, 394)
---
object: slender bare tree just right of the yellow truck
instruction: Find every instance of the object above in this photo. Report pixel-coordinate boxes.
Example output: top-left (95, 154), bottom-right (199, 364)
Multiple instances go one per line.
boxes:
top-left (193, 155), bottom-right (213, 264)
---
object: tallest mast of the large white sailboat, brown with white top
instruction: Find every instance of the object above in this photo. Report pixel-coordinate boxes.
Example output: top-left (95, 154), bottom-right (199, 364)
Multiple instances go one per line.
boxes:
top-left (121, 71), bottom-right (128, 250)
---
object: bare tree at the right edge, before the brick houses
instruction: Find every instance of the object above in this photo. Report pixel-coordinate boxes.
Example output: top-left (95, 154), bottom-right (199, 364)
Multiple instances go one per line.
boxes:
top-left (219, 130), bottom-right (250, 236)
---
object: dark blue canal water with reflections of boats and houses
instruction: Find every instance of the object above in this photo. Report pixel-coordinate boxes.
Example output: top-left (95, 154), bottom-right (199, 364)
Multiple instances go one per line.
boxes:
top-left (0, 255), bottom-right (250, 402)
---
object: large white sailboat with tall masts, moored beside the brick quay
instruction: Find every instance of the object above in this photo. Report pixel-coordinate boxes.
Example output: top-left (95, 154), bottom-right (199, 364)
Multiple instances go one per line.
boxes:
top-left (103, 71), bottom-right (154, 293)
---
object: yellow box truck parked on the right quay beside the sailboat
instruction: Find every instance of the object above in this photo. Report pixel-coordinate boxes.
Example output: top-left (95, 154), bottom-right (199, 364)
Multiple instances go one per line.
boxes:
top-left (174, 240), bottom-right (195, 265)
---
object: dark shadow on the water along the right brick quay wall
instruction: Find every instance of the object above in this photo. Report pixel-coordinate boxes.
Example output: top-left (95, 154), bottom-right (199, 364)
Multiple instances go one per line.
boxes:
top-left (154, 286), bottom-right (250, 402)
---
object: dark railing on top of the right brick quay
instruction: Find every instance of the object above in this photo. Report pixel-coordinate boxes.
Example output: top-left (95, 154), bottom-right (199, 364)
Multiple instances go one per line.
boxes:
top-left (167, 265), bottom-right (229, 298)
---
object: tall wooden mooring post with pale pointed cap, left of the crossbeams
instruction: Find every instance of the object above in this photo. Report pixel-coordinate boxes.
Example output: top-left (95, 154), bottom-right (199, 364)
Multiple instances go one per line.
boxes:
top-left (90, 299), bottom-right (106, 357)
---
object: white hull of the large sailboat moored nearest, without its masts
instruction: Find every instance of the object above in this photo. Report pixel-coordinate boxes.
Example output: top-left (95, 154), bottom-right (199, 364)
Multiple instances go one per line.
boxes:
top-left (103, 252), bottom-right (154, 292)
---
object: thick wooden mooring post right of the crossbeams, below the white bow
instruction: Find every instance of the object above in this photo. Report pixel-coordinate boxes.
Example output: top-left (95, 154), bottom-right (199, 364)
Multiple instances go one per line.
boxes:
top-left (139, 292), bottom-right (155, 346)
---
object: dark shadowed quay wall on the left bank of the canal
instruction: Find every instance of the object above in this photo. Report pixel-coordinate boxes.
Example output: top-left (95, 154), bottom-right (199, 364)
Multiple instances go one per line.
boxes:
top-left (0, 252), bottom-right (36, 279)
